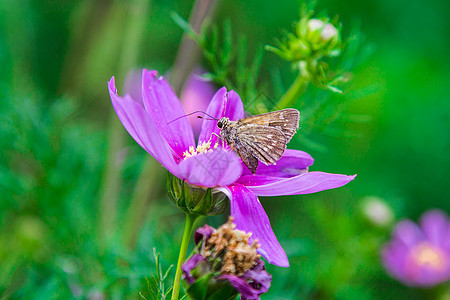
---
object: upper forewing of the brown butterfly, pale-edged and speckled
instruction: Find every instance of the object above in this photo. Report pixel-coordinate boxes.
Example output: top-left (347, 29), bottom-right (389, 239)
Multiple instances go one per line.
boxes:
top-left (237, 108), bottom-right (300, 144)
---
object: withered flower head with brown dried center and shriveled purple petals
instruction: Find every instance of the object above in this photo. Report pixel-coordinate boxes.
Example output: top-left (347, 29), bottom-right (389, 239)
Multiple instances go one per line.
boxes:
top-left (182, 217), bottom-right (272, 299)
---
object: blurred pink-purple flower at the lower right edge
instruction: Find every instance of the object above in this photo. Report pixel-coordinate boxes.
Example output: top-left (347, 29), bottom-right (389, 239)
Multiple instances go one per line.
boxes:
top-left (382, 210), bottom-right (450, 287)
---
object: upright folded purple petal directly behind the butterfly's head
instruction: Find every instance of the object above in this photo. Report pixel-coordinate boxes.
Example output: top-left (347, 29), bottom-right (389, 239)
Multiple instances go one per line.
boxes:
top-left (198, 87), bottom-right (244, 145)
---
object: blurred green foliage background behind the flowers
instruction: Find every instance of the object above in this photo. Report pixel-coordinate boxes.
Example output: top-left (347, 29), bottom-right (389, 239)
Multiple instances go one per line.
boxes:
top-left (0, 0), bottom-right (450, 299)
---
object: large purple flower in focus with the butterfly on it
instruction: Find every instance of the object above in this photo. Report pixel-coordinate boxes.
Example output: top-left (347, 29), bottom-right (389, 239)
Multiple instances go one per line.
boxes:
top-left (108, 69), bottom-right (356, 267)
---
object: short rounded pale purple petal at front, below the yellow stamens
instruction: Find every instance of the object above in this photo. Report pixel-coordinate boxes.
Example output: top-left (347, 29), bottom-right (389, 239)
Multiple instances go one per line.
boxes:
top-left (177, 148), bottom-right (242, 187)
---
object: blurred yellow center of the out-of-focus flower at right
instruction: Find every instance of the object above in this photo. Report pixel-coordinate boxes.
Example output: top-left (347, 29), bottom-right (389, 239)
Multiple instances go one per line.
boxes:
top-left (411, 242), bottom-right (447, 271)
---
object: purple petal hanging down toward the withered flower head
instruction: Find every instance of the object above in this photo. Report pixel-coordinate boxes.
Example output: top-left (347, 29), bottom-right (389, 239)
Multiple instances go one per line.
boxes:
top-left (218, 184), bottom-right (289, 267)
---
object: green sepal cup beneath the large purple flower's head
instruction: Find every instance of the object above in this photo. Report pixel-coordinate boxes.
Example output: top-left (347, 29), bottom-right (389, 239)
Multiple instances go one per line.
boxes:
top-left (167, 173), bottom-right (228, 216)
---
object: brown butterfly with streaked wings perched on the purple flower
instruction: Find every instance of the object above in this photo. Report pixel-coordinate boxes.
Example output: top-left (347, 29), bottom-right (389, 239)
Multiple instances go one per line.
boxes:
top-left (217, 108), bottom-right (300, 174)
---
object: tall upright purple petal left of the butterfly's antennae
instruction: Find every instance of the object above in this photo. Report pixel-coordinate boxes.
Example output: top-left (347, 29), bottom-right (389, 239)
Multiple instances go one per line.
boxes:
top-left (142, 69), bottom-right (195, 158)
